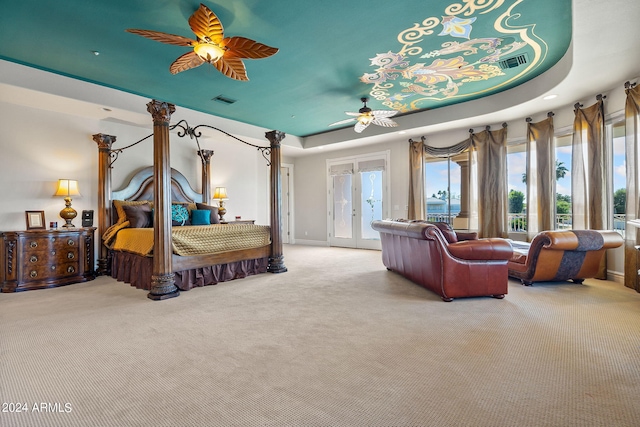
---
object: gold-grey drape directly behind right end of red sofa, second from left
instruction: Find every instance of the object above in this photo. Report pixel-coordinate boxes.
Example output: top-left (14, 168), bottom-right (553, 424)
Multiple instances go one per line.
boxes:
top-left (471, 124), bottom-right (508, 238)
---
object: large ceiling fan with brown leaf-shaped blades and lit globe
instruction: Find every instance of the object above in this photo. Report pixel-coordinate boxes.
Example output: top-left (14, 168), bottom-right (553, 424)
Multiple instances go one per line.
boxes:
top-left (126, 3), bottom-right (278, 80)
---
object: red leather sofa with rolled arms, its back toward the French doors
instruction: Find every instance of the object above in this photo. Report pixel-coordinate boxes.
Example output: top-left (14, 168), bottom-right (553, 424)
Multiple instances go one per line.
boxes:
top-left (371, 220), bottom-right (513, 302)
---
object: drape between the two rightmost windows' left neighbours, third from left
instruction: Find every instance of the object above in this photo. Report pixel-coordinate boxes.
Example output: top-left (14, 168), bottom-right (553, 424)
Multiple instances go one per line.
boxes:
top-left (527, 113), bottom-right (556, 240)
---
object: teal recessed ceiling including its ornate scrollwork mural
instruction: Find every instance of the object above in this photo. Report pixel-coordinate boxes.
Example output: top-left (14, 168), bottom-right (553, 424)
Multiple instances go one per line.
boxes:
top-left (0, 0), bottom-right (573, 137)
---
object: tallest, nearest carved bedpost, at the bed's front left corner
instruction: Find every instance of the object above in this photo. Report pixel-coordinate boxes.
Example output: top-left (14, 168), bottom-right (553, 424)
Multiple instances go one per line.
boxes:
top-left (147, 100), bottom-right (180, 300)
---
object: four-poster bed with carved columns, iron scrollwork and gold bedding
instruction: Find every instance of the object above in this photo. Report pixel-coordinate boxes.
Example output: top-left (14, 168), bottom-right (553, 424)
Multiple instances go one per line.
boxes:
top-left (93, 100), bottom-right (287, 300)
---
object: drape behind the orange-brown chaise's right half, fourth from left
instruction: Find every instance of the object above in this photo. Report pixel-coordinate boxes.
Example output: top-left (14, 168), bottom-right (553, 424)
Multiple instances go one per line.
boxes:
top-left (571, 95), bottom-right (608, 279)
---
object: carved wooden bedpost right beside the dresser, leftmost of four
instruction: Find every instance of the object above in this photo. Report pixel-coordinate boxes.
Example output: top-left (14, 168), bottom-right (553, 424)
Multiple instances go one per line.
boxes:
top-left (93, 133), bottom-right (116, 276)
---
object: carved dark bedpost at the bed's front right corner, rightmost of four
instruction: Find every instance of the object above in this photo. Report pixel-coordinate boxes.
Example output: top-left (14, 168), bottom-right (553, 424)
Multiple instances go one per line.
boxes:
top-left (265, 130), bottom-right (287, 273)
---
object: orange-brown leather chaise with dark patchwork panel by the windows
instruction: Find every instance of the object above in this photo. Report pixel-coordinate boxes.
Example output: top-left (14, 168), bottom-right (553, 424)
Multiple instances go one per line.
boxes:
top-left (507, 230), bottom-right (624, 286)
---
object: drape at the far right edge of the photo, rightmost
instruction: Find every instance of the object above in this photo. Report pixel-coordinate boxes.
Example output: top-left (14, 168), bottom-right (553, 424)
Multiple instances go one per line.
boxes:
top-left (624, 82), bottom-right (640, 292)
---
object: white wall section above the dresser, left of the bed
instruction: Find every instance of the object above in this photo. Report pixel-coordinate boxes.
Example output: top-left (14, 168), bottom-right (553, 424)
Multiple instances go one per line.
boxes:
top-left (0, 102), bottom-right (99, 230)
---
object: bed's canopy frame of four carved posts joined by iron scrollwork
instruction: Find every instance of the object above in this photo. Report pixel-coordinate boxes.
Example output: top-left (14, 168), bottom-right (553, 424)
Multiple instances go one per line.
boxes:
top-left (93, 100), bottom-right (287, 300)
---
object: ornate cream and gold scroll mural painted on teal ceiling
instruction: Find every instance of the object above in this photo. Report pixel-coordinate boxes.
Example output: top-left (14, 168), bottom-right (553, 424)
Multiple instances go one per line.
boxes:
top-left (360, 0), bottom-right (547, 113)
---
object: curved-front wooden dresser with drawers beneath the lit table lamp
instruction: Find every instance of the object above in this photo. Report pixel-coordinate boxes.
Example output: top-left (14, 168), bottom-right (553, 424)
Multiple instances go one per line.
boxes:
top-left (0, 227), bottom-right (96, 292)
